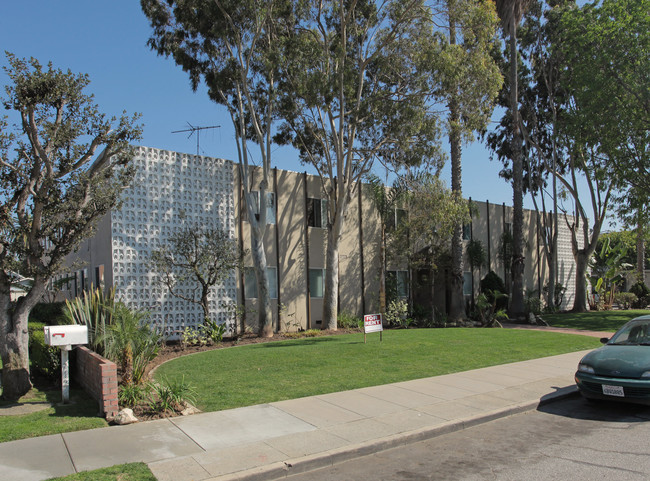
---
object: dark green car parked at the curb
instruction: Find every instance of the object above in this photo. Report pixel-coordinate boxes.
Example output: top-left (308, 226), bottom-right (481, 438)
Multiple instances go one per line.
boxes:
top-left (575, 316), bottom-right (650, 405)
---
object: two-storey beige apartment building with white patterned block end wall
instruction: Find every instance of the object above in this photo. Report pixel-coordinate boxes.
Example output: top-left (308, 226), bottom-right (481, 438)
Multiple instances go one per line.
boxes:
top-left (59, 147), bottom-right (575, 332)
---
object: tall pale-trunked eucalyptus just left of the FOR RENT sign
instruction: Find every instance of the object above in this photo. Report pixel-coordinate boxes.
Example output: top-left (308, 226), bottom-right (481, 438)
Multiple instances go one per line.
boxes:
top-left (277, 0), bottom-right (440, 329)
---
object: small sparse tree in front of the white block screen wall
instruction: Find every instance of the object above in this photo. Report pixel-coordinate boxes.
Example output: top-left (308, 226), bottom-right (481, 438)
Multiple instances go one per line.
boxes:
top-left (151, 225), bottom-right (241, 334)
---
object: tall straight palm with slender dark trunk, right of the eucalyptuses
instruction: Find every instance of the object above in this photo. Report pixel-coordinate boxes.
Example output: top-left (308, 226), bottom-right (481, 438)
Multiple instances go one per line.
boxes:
top-left (496, 0), bottom-right (528, 315)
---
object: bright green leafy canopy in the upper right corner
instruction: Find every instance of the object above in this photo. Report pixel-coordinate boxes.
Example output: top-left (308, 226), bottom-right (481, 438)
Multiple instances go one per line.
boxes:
top-left (557, 0), bottom-right (650, 192)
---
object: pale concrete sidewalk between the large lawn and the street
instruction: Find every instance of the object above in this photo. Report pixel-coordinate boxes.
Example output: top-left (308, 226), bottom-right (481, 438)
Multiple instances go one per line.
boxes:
top-left (0, 351), bottom-right (588, 481)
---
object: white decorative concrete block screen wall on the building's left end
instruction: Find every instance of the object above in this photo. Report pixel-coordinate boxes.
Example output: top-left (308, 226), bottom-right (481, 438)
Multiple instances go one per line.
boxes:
top-left (111, 147), bottom-right (236, 333)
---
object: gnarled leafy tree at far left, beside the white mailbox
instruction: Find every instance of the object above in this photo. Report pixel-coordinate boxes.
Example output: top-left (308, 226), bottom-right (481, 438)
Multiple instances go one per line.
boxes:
top-left (0, 54), bottom-right (140, 400)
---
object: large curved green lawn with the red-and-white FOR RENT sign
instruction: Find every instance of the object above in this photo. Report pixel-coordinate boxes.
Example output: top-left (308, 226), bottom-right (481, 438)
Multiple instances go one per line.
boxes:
top-left (156, 329), bottom-right (599, 411)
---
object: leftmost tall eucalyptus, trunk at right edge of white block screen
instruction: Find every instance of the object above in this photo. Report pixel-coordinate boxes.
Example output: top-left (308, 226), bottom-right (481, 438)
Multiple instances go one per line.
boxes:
top-left (140, 0), bottom-right (293, 337)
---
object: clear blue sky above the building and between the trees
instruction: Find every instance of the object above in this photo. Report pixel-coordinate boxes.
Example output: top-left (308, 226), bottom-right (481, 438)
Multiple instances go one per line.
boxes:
top-left (0, 0), bottom-right (572, 214)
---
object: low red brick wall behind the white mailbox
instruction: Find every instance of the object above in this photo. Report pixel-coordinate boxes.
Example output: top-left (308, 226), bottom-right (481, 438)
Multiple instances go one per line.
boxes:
top-left (75, 346), bottom-right (119, 419)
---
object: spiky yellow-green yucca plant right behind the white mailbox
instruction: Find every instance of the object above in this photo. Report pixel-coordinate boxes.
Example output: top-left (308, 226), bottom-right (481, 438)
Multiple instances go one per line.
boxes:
top-left (63, 288), bottom-right (115, 355)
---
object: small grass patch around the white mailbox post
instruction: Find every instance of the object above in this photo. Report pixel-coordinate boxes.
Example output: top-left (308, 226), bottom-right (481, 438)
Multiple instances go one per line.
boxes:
top-left (0, 388), bottom-right (108, 442)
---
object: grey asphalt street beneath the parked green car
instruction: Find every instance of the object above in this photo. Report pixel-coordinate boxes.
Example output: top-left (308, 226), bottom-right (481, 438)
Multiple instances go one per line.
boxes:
top-left (288, 395), bottom-right (650, 481)
